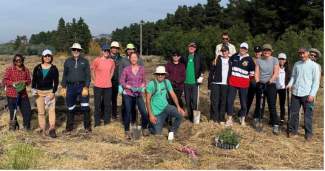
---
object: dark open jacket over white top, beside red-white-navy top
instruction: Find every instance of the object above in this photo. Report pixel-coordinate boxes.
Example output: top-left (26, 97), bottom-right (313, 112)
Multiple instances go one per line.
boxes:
top-left (208, 56), bottom-right (232, 89)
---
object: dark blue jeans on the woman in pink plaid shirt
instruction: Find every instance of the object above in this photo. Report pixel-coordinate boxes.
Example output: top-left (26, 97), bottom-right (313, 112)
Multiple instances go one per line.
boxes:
top-left (123, 95), bottom-right (149, 131)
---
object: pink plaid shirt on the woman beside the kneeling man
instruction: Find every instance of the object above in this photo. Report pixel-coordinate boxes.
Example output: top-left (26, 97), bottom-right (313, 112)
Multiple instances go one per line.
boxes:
top-left (120, 65), bottom-right (146, 96)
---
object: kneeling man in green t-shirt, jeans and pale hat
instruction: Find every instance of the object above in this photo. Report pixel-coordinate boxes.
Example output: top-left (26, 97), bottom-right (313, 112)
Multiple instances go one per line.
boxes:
top-left (146, 66), bottom-right (185, 134)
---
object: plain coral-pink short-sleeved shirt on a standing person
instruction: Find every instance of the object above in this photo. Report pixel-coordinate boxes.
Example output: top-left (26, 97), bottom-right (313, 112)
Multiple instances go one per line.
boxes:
top-left (91, 57), bottom-right (115, 88)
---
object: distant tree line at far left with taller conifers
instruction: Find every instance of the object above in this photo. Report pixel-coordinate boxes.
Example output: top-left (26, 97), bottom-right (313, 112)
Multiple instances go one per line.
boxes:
top-left (0, 17), bottom-right (92, 55)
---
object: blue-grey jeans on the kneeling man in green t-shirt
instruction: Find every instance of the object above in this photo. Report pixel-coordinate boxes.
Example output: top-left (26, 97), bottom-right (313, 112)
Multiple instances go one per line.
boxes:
top-left (150, 105), bottom-right (182, 134)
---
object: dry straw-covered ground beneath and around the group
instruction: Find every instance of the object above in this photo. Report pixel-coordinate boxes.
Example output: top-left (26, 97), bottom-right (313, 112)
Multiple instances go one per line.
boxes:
top-left (0, 56), bottom-right (324, 169)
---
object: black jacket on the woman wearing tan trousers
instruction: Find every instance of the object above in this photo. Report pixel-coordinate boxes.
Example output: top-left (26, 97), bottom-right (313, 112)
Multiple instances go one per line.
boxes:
top-left (32, 64), bottom-right (59, 93)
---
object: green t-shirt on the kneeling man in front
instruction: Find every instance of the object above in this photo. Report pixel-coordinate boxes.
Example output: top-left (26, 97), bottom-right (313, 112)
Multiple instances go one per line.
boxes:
top-left (146, 80), bottom-right (173, 116)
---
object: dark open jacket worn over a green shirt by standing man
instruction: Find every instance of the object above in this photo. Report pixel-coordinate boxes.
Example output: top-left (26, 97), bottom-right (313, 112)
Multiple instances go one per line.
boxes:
top-left (181, 53), bottom-right (205, 81)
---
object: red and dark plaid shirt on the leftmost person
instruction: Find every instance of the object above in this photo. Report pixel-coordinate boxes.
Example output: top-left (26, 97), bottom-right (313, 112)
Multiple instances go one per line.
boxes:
top-left (3, 66), bottom-right (31, 97)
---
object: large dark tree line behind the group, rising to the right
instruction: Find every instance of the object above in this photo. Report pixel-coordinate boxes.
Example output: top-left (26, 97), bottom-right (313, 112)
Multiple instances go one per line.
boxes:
top-left (112, 0), bottom-right (324, 63)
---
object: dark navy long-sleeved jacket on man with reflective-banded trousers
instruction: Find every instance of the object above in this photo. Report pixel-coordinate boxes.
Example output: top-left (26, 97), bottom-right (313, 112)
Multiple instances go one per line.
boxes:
top-left (61, 57), bottom-right (90, 87)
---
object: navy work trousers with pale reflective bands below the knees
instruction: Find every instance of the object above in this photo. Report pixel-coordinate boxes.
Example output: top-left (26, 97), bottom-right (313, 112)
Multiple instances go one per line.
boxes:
top-left (66, 83), bottom-right (90, 130)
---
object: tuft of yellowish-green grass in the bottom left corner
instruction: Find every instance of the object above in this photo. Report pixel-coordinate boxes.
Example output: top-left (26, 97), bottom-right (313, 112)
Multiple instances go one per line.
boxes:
top-left (1, 143), bottom-right (40, 170)
